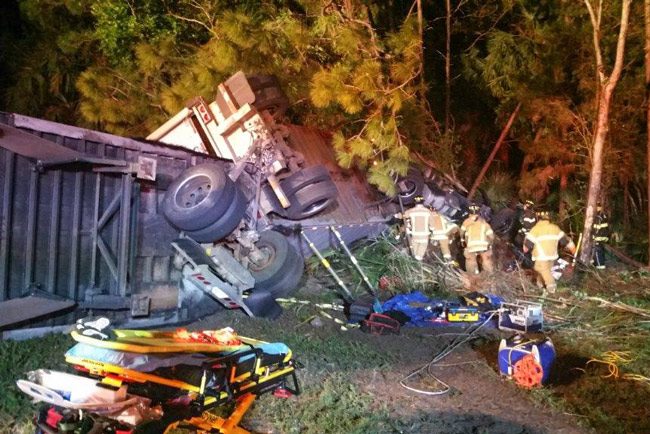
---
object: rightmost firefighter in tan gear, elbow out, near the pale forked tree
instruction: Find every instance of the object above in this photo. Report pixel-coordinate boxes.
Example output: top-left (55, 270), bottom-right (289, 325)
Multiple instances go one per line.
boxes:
top-left (524, 211), bottom-right (576, 294)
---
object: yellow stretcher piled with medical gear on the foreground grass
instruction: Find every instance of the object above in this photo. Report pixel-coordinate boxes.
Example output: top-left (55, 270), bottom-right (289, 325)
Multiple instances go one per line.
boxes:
top-left (18, 329), bottom-right (300, 434)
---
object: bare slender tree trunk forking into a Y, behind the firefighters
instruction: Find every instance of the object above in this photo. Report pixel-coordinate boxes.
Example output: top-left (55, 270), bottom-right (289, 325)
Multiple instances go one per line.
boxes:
top-left (580, 0), bottom-right (632, 264)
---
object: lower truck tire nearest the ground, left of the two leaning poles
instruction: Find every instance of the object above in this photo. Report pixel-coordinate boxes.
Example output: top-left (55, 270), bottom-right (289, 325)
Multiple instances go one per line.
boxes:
top-left (249, 231), bottom-right (305, 298)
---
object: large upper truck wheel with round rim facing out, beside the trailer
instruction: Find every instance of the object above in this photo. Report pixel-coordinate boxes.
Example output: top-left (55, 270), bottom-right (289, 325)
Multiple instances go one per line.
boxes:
top-left (162, 163), bottom-right (235, 231)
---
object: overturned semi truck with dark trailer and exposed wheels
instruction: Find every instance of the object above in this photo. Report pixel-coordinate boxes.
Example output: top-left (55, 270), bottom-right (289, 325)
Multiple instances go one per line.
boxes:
top-left (0, 73), bottom-right (388, 330)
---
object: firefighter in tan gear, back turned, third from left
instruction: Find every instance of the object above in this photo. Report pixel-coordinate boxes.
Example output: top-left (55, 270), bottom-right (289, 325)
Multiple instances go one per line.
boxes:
top-left (460, 204), bottom-right (494, 274)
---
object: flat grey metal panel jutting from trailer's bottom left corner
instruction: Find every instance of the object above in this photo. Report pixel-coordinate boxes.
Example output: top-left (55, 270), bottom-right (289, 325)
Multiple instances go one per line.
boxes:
top-left (0, 295), bottom-right (75, 328)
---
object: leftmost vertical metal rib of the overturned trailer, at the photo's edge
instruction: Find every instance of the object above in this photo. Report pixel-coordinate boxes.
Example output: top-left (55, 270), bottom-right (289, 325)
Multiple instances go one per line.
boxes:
top-left (0, 151), bottom-right (16, 300)
